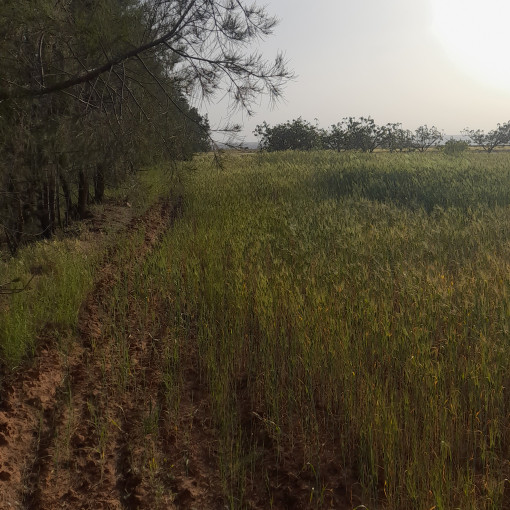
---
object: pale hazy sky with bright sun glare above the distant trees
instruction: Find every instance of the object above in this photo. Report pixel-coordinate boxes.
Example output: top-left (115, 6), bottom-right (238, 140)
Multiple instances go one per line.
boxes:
top-left (201, 0), bottom-right (510, 142)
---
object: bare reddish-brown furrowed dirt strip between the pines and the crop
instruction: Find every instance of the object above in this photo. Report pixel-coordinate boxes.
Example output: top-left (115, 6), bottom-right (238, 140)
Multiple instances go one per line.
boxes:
top-left (0, 199), bottom-right (223, 509)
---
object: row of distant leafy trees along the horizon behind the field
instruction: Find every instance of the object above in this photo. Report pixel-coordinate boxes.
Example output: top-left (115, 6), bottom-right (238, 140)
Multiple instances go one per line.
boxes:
top-left (254, 117), bottom-right (510, 154)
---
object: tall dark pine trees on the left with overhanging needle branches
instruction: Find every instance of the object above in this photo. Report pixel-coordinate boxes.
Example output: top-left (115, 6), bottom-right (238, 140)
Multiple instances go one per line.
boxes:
top-left (0, 0), bottom-right (291, 253)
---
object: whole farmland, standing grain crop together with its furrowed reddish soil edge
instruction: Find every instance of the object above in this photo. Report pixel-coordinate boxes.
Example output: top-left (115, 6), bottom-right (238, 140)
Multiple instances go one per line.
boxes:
top-left (0, 152), bottom-right (510, 510)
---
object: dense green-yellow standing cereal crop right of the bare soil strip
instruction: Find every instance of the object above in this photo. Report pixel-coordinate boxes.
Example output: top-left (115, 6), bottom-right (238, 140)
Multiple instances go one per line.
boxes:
top-left (149, 153), bottom-right (510, 509)
